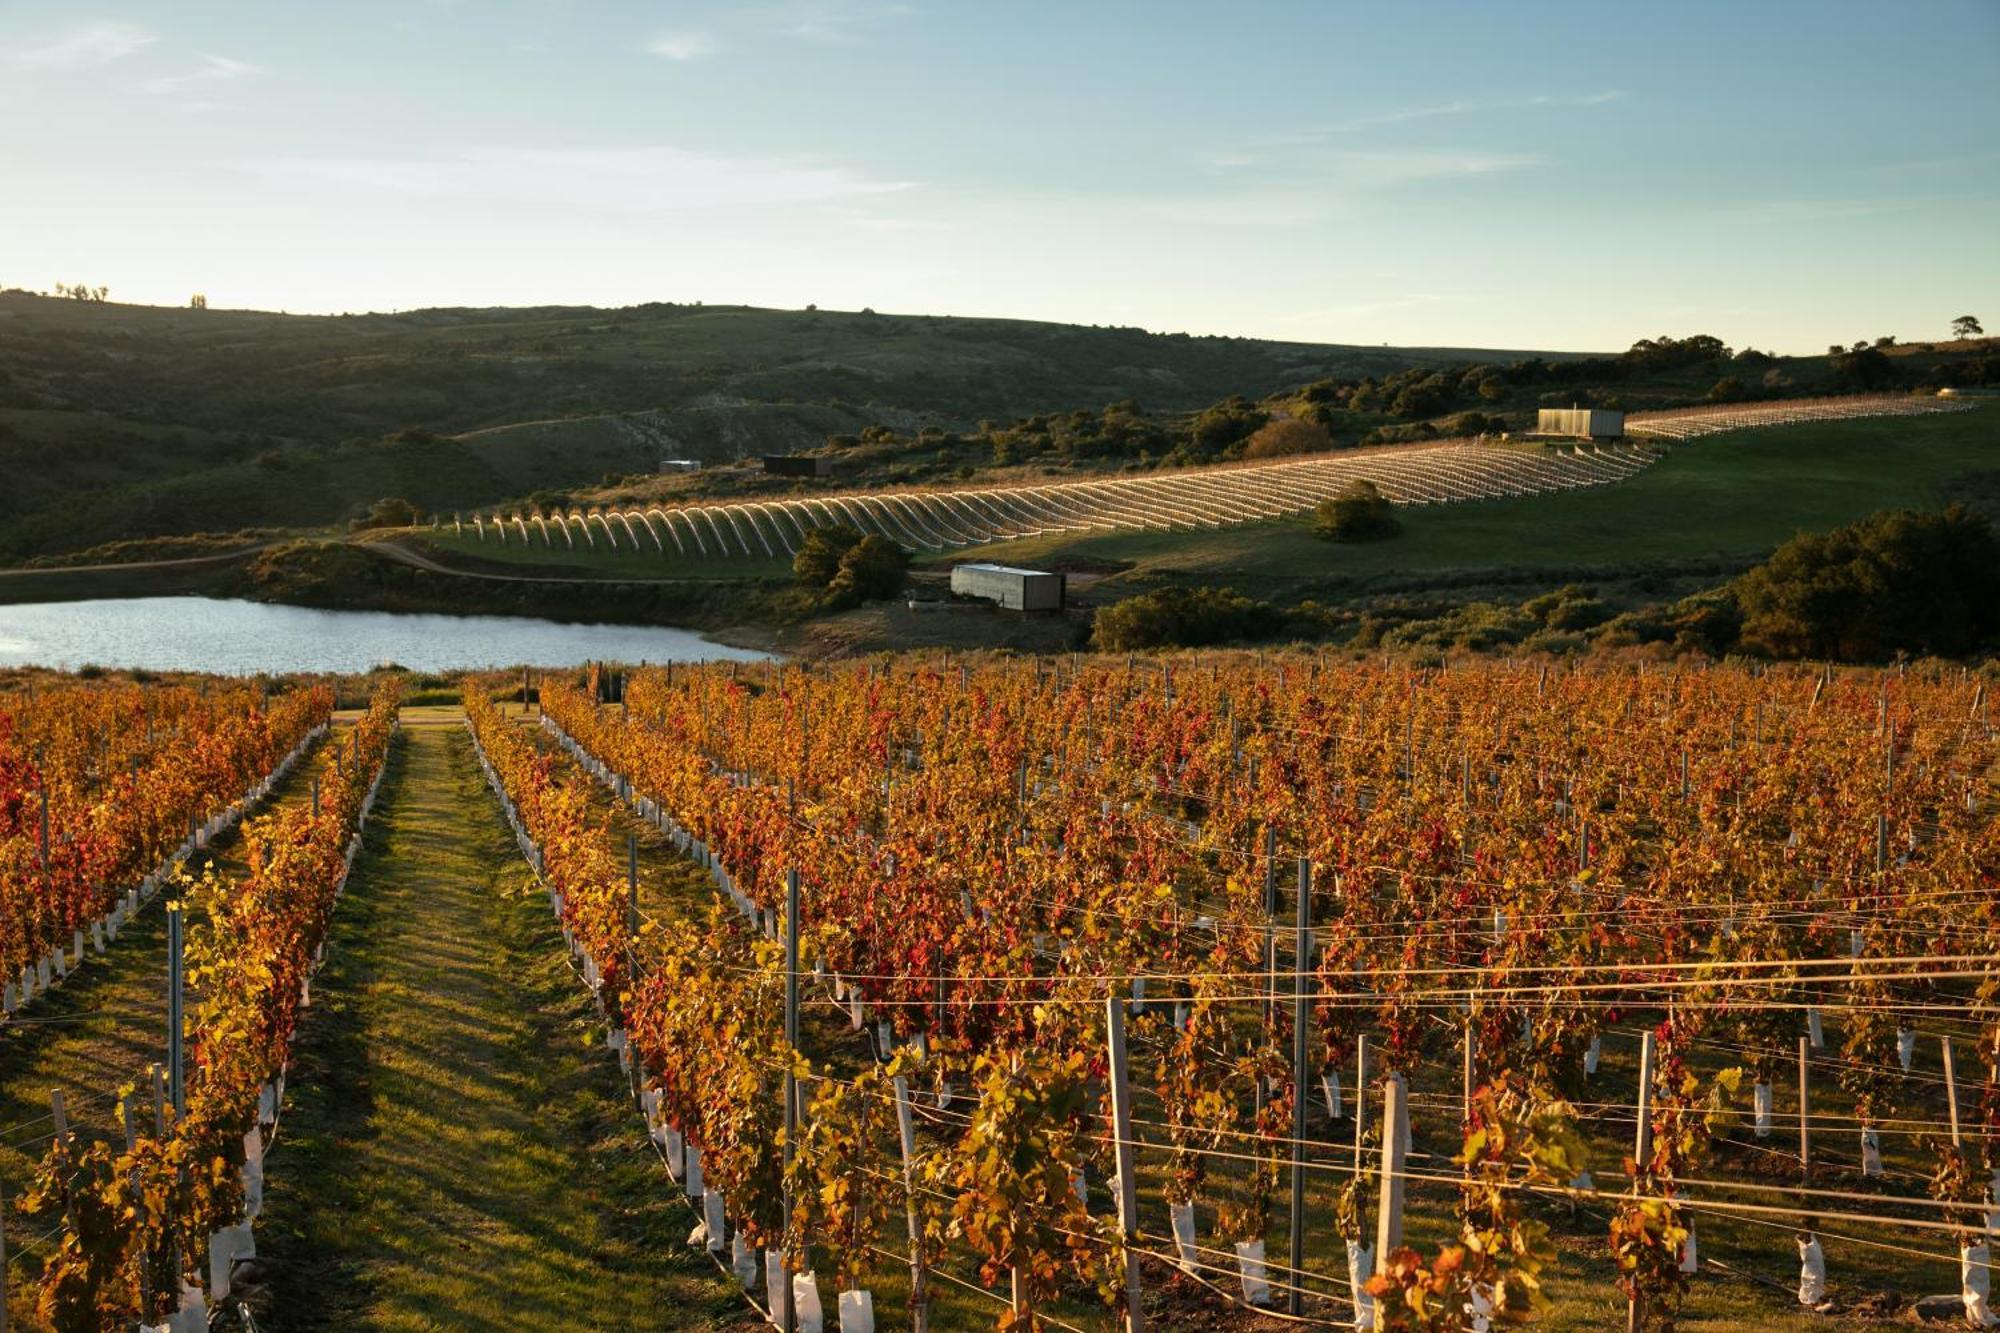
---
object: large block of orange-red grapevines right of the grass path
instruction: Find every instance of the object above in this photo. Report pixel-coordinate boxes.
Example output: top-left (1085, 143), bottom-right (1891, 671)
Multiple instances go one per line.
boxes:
top-left (488, 656), bottom-right (2000, 1327)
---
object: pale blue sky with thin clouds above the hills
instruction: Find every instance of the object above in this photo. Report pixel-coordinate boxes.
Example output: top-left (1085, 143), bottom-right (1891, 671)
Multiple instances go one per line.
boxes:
top-left (0, 0), bottom-right (2000, 352)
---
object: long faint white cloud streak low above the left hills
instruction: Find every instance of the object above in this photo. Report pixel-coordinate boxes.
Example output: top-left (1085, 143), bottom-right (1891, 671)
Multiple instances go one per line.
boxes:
top-left (230, 146), bottom-right (910, 214)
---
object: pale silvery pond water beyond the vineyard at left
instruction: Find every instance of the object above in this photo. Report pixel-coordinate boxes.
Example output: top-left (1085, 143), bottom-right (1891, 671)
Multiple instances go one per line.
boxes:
top-left (0, 596), bottom-right (766, 677)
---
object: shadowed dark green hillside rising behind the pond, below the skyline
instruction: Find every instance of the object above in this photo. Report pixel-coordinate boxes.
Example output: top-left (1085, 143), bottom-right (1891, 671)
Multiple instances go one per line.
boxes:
top-left (0, 292), bottom-right (1584, 556)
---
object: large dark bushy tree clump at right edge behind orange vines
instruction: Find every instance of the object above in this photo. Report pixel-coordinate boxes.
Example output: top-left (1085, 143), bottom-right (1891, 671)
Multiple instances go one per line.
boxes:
top-left (1734, 504), bottom-right (2000, 660)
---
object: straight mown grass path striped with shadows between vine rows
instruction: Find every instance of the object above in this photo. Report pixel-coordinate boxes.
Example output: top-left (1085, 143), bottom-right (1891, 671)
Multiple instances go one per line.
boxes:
top-left (252, 711), bottom-right (742, 1329)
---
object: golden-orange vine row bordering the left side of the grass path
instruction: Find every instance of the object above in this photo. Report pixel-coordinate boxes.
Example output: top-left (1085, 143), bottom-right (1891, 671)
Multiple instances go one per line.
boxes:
top-left (0, 681), bottom-right (398, 1333)
